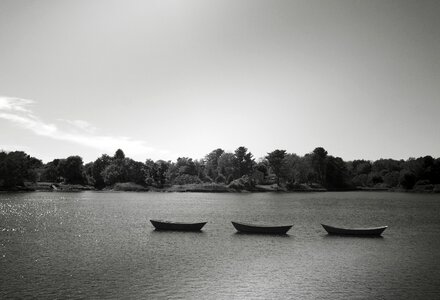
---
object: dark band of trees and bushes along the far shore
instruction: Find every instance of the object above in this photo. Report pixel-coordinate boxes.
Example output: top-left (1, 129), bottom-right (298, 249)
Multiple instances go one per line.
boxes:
top-left (0, 147), bottom-right (440, 193)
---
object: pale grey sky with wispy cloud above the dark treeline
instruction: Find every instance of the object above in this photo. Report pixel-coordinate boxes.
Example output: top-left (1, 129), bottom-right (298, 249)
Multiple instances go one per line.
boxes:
top-left (0, 0), bottom-right (440, 162)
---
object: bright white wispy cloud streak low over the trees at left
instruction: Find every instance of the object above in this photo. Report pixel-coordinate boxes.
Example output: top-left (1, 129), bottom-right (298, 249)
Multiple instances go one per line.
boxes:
top-left (0, 96), bottom-right (167, 156)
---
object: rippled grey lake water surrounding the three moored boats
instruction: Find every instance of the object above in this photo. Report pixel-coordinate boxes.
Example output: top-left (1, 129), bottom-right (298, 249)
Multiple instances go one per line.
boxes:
top-left (0, 192), bottom-right (440, 299)
